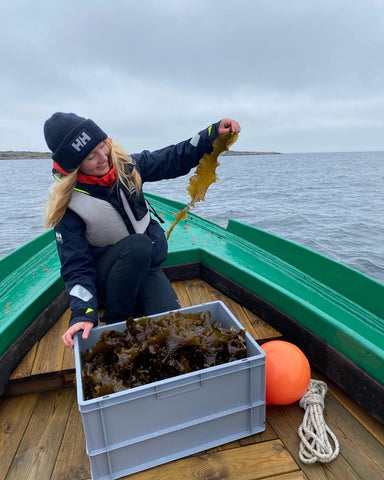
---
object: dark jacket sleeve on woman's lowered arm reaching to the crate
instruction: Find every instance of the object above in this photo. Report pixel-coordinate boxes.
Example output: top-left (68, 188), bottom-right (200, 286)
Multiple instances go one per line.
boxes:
top-left (55, 209), bottom-right (98, 326)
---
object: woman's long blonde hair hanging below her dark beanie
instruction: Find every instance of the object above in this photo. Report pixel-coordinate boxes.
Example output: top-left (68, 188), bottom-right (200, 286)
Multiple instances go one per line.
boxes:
top-left (45, 138), bottom-right (142, 228)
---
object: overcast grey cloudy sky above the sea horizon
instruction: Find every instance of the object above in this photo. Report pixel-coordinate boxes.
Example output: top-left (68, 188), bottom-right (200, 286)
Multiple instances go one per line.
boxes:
top-left (0, 0), bottom-right (384, 152)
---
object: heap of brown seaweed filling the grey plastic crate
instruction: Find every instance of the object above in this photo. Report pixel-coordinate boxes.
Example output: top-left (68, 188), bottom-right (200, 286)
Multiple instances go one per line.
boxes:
top-left (81, 311), bottom-right (246, 400)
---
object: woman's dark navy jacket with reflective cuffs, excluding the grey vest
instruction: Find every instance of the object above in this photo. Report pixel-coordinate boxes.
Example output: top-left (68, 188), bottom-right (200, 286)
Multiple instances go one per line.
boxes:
top-left (55, 123), bottom-right (219, 325)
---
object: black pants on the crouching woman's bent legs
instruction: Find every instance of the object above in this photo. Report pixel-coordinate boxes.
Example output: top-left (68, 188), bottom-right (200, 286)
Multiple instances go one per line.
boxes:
top-left (97, 234), bottom-right (180, 323)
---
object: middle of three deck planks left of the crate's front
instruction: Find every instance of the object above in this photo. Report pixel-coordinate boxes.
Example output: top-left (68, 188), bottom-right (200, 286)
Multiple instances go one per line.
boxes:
top-left (6, 389), bottom-right (74, 480)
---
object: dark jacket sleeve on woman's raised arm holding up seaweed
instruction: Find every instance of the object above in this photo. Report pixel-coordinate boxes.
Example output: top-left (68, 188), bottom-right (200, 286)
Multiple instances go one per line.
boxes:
top-left (132, 122), bottom-right (220, 183)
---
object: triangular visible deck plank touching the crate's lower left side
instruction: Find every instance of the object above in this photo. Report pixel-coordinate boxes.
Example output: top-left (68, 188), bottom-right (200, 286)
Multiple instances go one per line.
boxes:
top-left (50, 390), bottom-right (90, 480)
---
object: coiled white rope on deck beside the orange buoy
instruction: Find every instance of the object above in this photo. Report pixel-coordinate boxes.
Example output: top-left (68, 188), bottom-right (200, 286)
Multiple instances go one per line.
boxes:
top-left (299, 379), bottom-right (340, 464)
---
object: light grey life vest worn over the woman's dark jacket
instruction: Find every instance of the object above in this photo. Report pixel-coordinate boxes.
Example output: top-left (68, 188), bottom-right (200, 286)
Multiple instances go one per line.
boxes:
top-left (68, 189), bottom-right (151, 247)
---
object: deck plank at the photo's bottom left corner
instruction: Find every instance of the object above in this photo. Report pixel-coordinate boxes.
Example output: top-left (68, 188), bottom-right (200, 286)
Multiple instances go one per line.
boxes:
top-left (0, 395), bottom-right (39, 480)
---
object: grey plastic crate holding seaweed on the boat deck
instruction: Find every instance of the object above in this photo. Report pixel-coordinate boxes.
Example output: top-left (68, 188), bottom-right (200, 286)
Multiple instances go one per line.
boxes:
top-left (75, 301), bottom-right (265, 480)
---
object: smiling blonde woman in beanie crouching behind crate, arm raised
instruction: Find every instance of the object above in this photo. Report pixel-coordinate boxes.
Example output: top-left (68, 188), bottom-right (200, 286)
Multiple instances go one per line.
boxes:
top-left (44, 112), bottom-right (240, 348)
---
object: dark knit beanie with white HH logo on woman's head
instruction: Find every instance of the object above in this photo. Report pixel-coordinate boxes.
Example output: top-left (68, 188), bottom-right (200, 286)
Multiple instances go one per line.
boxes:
top-left (44, 112), bottom-right (107, 173)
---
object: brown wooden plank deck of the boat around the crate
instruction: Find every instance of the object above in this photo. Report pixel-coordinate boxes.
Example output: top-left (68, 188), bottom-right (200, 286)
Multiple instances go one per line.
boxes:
top-left (0, 279), bottom-right (384, 480)
